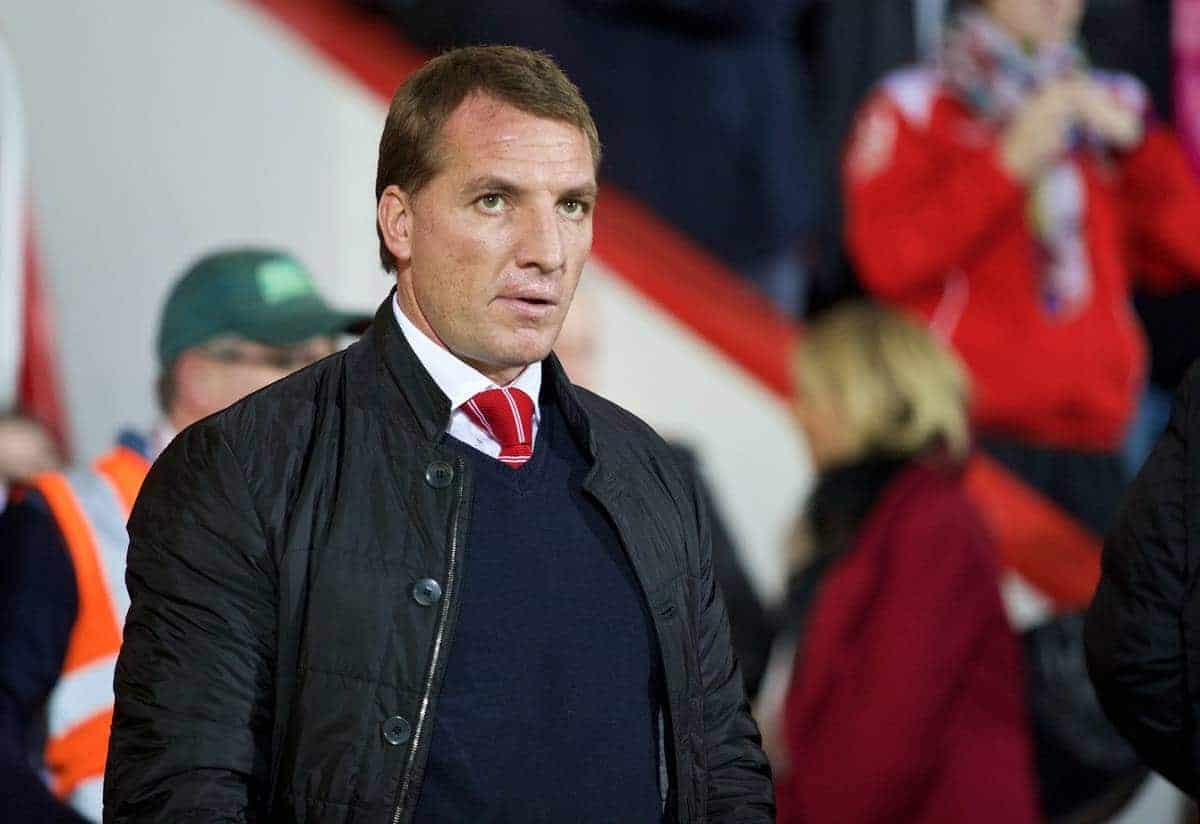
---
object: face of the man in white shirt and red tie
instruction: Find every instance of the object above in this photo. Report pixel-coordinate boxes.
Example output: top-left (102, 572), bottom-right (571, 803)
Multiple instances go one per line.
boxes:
top-left (379, 95), bottom-right (596, 384)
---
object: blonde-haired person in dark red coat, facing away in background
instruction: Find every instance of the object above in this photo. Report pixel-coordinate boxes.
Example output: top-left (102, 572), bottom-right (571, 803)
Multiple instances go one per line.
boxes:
top-left (775, 305), bottom-right (1038, 824)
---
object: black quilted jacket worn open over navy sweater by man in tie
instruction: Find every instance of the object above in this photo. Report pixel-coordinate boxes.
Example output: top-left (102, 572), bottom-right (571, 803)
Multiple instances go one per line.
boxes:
top-left (104, 299), bottom-right (774, 824)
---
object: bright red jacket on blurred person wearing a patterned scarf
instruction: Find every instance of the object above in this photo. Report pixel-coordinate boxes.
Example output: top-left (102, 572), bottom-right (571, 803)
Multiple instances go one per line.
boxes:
top-left (844, 68), bottom-right (1200, 451)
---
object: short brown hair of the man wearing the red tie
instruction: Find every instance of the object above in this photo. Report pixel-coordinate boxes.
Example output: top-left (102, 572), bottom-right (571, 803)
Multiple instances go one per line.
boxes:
top-left (376, 46), bottom-right (600, 271)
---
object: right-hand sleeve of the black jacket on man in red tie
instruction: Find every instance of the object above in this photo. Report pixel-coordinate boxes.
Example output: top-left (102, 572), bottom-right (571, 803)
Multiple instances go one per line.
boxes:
top-left (690, 465), bottom-right (775, 823)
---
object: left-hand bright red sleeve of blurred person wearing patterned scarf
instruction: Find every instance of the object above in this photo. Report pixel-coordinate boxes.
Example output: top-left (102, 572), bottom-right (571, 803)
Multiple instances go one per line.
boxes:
top-left (842, 90), bottom-right (1025, 300)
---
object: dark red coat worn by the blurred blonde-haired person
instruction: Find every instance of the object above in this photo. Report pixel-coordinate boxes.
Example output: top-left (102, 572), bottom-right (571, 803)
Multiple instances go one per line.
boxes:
top-left (775, 465), bottom-right (1038, 824)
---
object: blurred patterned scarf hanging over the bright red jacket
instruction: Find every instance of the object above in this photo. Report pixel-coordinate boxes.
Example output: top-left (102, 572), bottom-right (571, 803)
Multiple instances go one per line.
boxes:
top-left (938, 11), bottom-right (1103, 321)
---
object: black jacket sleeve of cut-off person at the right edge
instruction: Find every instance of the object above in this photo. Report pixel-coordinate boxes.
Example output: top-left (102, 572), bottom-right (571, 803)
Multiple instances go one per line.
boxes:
top-left (1084, 367), bottom-right (1200, 795)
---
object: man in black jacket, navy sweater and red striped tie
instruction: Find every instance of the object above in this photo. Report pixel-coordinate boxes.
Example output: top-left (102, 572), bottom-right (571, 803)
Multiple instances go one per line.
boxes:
top-left (104, 47), bottom-right (774, 823)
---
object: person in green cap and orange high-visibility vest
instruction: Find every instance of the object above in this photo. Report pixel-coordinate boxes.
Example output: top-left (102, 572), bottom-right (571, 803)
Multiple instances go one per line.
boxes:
top-left (0, 248), bottom-right (365, 822)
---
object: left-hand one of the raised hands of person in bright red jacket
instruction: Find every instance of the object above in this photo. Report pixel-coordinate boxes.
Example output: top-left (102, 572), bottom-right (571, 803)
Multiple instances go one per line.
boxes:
top-left (1000, 78), bottom-right (1081, 181)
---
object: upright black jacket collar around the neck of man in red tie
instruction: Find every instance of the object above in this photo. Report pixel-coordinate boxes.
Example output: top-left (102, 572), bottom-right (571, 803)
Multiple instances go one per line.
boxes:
top-left (370, 289), bottom-right (596, 462)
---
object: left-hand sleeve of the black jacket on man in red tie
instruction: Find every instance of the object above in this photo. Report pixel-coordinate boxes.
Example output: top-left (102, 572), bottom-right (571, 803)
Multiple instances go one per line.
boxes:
top-left (104, 423), bottom-right (276, 824)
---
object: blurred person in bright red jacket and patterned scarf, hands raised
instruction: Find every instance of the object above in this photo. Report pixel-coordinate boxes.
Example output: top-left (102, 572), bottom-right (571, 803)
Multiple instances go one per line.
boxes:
top-left (844, 0), bottom-right (1200, 531)
